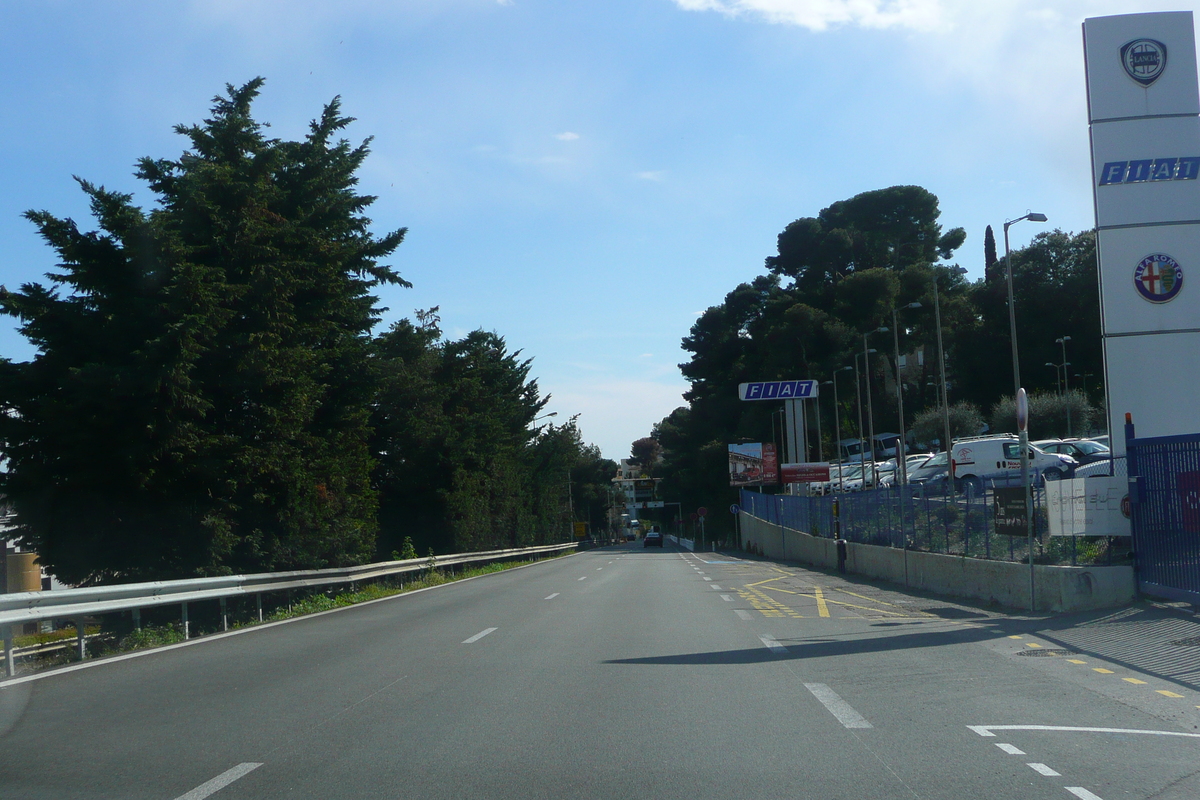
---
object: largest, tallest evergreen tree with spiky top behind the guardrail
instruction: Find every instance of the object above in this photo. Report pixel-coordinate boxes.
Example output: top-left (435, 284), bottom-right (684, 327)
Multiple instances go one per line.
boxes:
top-left (0, 79), bottom-right (404, 583)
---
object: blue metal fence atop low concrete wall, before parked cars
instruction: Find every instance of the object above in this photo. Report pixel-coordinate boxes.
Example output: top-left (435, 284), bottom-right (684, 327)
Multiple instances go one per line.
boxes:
top-left (740, 483), bottom-right (1124, 564)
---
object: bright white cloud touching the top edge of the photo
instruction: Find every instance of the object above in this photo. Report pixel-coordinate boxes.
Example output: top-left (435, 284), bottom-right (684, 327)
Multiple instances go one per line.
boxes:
top-left (676, 0), bottom-right (946, 31)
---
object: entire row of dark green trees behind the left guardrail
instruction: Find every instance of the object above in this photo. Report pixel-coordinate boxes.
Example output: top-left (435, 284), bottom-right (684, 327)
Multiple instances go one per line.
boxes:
top-left (0, 78), bottom-right (616, 584)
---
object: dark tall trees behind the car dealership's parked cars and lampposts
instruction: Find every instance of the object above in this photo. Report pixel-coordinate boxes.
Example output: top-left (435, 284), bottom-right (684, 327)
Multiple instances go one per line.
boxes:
top-left (652, 186), bottom-right (1103, 532)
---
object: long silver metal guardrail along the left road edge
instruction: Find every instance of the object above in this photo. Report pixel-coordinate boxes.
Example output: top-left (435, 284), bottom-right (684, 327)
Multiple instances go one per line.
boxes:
top-left (0, 542), bottom-right (576, 676)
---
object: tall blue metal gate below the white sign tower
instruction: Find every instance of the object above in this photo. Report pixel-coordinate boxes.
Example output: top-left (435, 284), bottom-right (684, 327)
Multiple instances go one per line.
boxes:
top-left (1126, 423), bottom-right (1200, 603)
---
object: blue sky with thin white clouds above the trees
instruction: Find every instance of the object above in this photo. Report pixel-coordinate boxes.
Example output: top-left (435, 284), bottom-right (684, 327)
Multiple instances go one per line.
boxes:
top-left (0, 0), bottom-right (1192, 458)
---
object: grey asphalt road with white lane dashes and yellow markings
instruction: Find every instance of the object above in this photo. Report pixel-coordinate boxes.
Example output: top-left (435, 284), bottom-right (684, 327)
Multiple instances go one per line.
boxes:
top-left (0, 543), bottom-right (1200, 800)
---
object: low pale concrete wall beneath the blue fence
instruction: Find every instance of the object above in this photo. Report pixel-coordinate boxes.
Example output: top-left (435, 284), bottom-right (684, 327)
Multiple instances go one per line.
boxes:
top-left (740, 511), bottom-right (1138, 612)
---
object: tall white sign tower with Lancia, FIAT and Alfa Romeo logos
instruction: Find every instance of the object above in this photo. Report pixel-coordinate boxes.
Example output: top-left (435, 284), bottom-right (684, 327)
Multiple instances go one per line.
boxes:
top-left (1084, 11), bottom-right (1200, 455)
